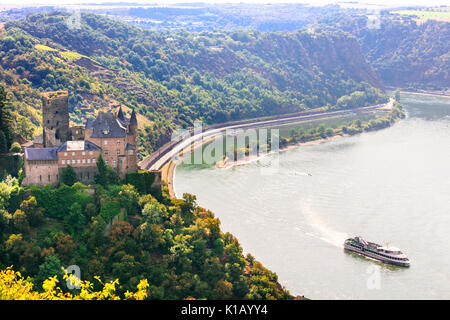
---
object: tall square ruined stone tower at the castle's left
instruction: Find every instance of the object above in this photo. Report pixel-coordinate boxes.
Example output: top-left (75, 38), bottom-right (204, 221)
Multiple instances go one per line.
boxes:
top-left (42, 90), bottom-right (70, 147)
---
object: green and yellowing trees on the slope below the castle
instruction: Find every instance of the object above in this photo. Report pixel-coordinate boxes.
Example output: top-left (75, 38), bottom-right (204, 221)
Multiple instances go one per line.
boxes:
top-left (0, 175), bottom-right (293, 299)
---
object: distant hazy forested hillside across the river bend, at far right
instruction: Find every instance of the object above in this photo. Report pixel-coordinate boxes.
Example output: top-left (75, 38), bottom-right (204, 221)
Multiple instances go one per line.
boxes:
top-left (321, 13), bottom-right (450, 90)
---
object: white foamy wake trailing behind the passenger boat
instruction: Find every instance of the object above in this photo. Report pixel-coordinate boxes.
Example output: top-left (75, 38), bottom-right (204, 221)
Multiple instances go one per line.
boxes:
top-left (300, 203), bottom-right (349, 248)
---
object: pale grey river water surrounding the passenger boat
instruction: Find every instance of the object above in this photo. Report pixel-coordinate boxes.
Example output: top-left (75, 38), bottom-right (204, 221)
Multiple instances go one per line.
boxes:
top-left (175, 94), bottom-right (450, 299)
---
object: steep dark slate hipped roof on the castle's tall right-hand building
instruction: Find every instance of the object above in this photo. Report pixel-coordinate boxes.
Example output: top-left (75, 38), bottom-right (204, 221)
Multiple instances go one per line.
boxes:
top-left (91, 112), bottom-right (127, 138)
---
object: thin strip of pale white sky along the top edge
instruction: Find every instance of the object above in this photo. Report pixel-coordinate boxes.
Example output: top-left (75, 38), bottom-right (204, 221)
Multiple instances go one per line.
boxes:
top-left (0, 0), bottom-right (450, 7)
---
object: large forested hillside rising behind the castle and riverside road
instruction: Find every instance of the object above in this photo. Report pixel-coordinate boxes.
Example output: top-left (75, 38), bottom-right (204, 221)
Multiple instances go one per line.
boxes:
top-left (0, 12), bottom-right (382, 157)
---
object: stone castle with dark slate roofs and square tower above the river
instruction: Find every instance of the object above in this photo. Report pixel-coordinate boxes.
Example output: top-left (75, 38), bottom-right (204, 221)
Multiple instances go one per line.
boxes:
top-left (22, 91), bottom-right (138, 185)
